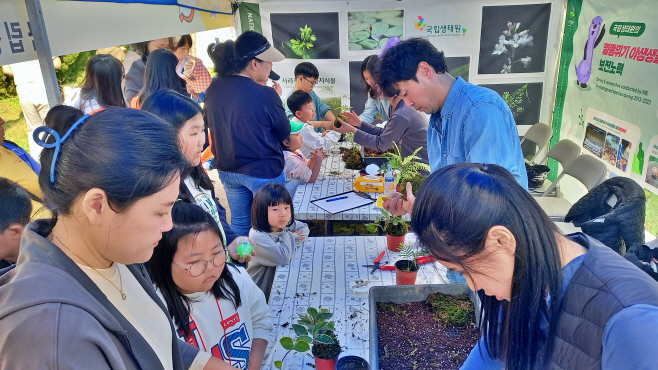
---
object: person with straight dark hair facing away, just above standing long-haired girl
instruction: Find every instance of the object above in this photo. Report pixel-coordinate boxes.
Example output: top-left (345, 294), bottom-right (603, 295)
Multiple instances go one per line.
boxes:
top-left (130, 49), bottom-right (187, 109)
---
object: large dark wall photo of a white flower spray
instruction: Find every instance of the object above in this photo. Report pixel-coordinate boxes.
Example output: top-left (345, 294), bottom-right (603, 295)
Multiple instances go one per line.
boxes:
top-left (478, 3), bottom-right (551, 74)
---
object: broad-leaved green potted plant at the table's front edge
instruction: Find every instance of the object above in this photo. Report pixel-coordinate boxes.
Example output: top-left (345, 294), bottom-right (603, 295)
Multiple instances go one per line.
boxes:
top-left (274, 307), bottom-right (342, 370)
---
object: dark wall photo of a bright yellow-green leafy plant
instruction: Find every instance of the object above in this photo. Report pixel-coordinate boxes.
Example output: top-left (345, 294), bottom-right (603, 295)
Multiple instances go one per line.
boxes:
top-left (270, 13), bottom-right (340, 59)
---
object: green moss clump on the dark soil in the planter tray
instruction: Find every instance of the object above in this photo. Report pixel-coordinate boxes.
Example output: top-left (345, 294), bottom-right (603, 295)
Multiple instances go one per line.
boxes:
top-left (426, 293), bottom-right (475, 327)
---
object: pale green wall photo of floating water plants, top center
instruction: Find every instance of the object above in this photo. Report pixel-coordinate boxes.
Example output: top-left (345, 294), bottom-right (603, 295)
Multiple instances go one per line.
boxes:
top-left (347, 10), bottom-right (404, 51)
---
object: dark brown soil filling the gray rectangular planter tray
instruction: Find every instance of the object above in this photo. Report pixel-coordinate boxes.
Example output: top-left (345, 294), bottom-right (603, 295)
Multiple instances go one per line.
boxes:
top-left (377, 296), bottom-right (479, 370)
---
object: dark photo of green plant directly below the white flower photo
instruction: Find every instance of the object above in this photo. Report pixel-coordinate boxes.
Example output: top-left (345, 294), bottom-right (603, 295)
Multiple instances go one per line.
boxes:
top-left (480, 82), bottom-right (544, 125)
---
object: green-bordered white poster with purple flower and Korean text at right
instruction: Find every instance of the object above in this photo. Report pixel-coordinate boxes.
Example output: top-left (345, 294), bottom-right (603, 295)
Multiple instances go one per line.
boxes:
top-left (553, 0), bottom-right (658, 201)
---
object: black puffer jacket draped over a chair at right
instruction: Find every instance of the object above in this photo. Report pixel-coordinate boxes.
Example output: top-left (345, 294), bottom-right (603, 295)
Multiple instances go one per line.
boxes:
top-left (564, 176), bottom-right (647, 256)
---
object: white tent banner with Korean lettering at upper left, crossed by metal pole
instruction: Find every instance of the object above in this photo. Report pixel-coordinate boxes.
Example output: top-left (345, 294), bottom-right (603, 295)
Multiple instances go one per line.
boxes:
top-left (0, 0), bottom-right (233, 65)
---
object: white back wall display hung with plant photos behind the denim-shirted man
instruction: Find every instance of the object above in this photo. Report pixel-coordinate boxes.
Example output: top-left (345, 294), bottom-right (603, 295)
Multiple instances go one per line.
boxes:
top-left (239, 0), bottom-right (564, 134)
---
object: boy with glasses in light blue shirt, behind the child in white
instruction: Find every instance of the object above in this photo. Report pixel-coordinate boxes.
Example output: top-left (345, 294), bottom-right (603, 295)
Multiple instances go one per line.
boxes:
top-left (286, 62), bottom-right (336, 130)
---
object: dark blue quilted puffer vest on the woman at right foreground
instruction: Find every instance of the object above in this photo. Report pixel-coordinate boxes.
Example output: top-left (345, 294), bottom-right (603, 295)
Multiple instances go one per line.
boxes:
top-left (549, 233), bottom-right (658, 370)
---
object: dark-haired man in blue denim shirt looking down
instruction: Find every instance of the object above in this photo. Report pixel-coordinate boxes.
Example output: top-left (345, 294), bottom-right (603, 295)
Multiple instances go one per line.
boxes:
top-left (379, 38), bottom-right (528, 189)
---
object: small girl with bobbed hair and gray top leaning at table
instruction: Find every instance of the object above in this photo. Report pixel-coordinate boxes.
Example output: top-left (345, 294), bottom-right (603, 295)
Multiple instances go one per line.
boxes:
top-left (247, 183), bottom-right (309, 302)
